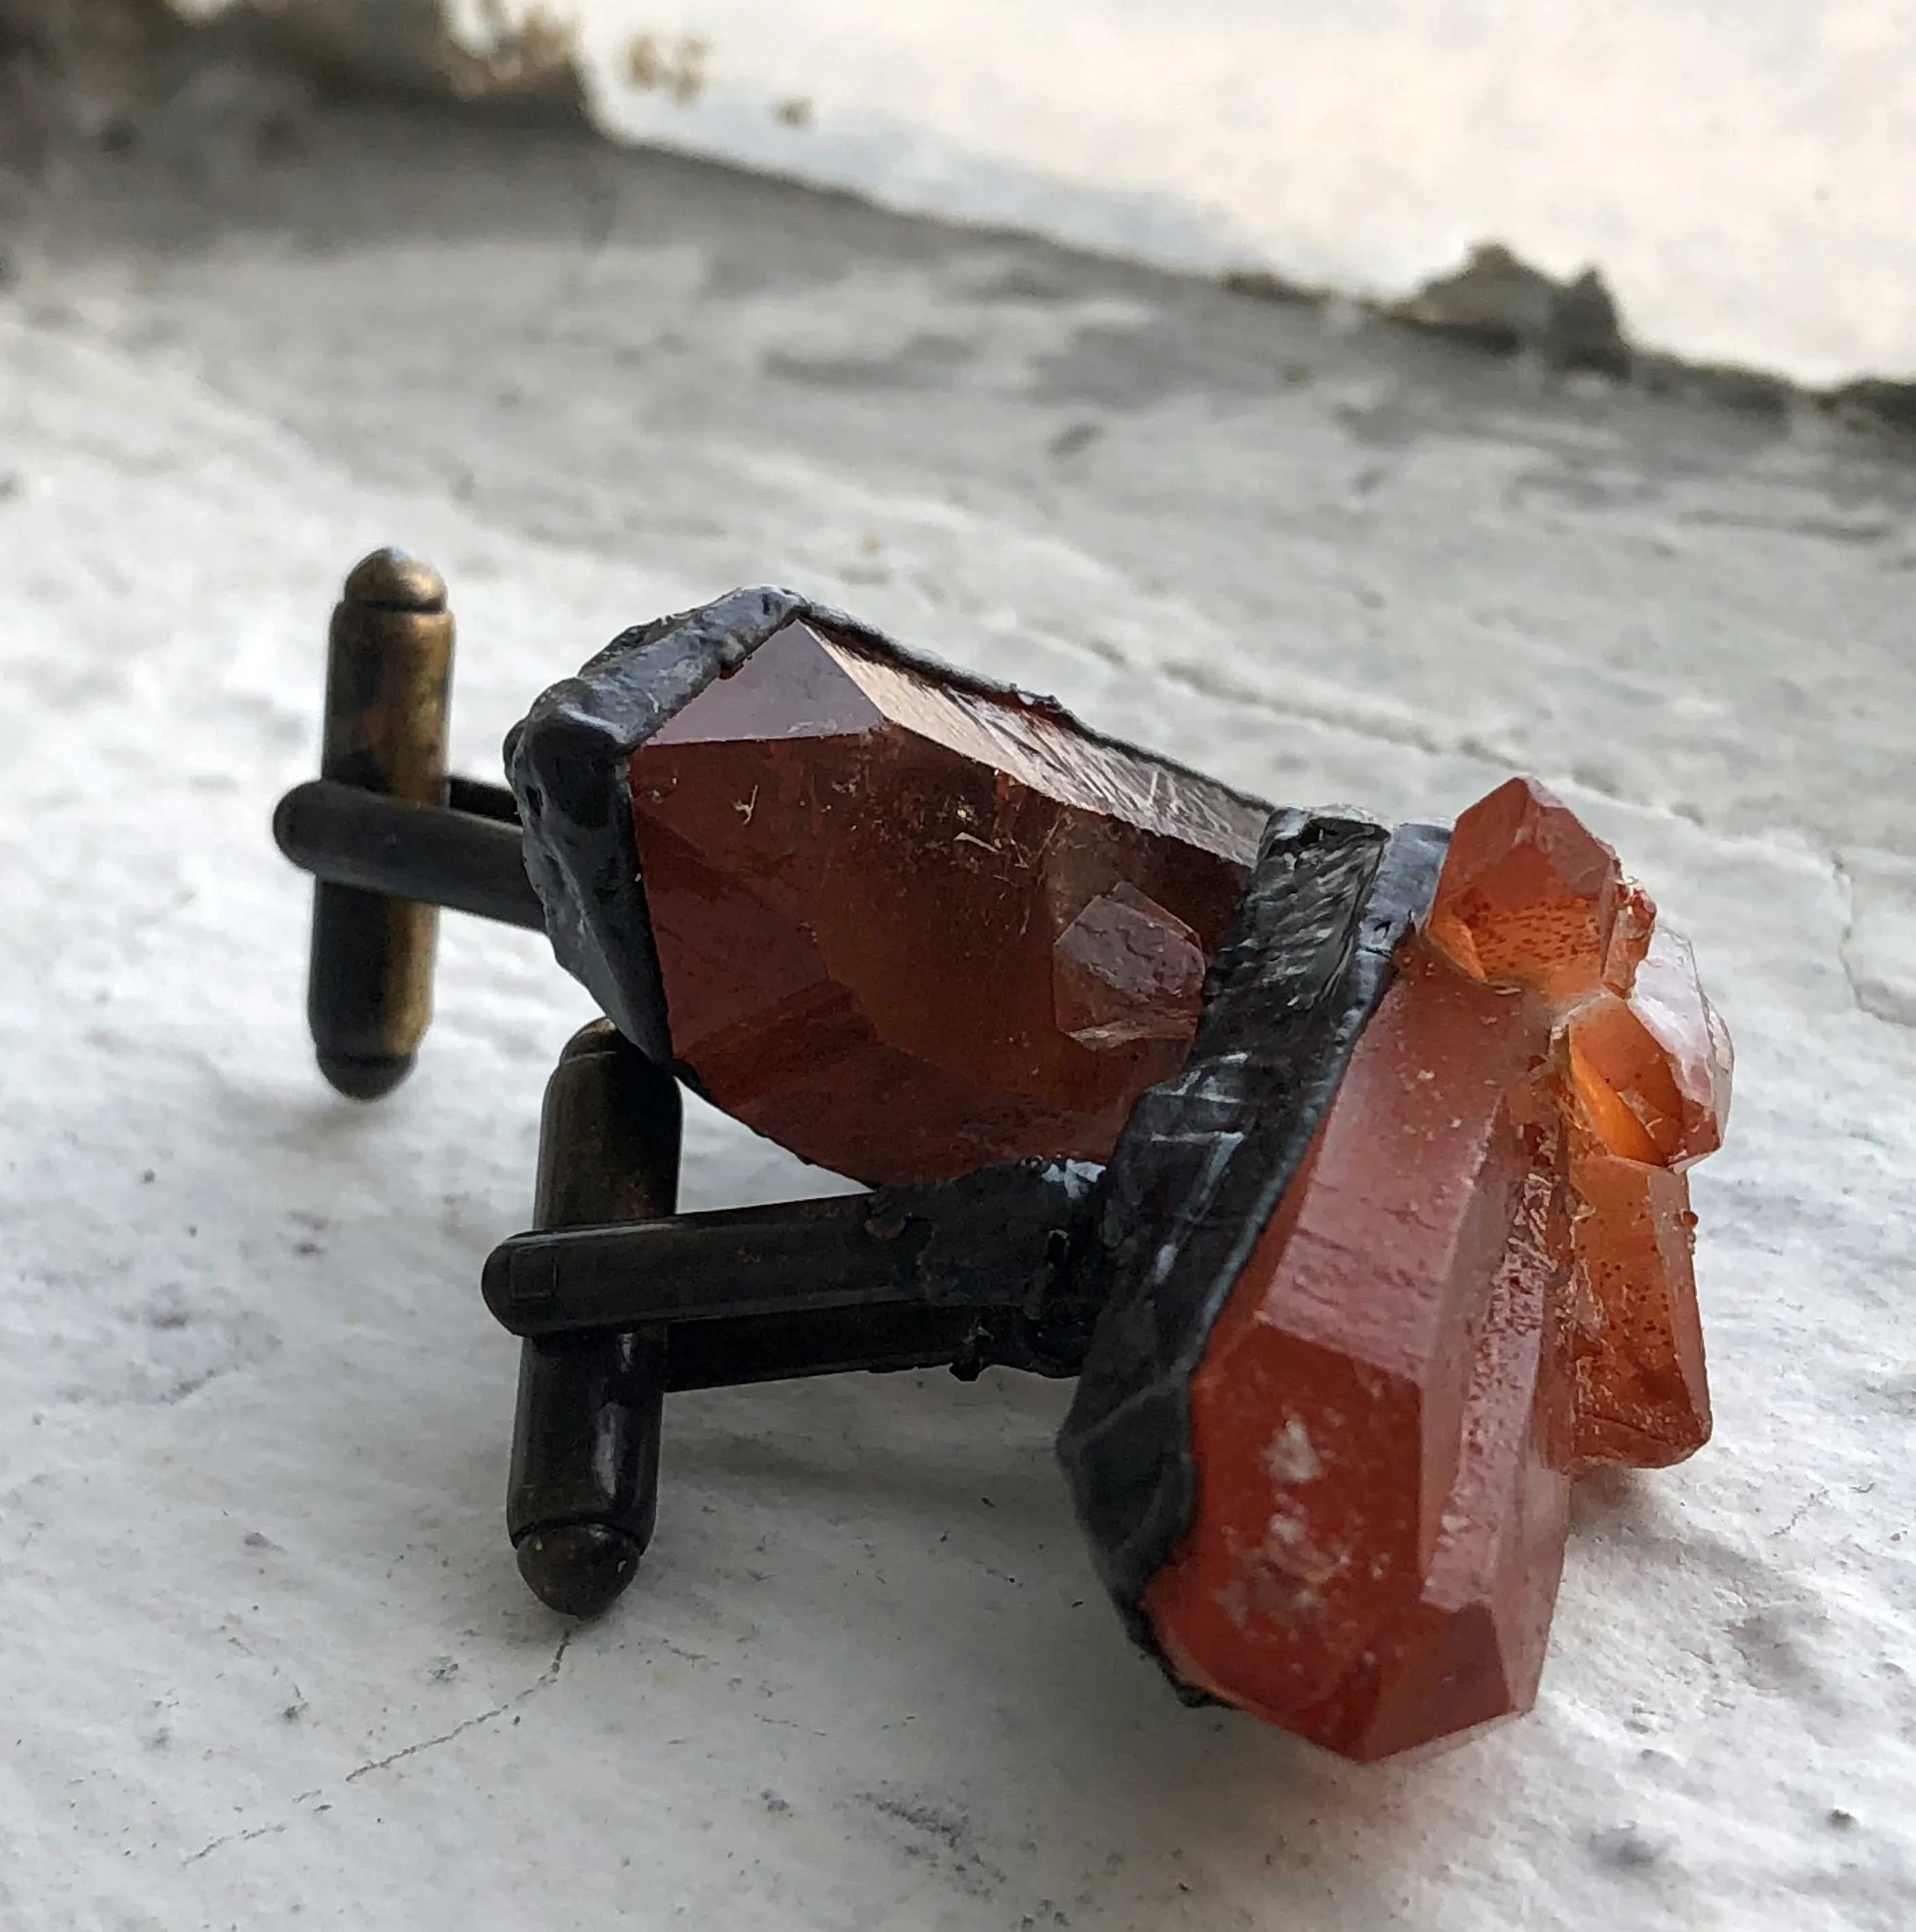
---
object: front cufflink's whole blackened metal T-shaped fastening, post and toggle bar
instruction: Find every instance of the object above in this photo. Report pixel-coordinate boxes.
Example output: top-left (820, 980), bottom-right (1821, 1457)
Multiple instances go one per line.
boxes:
top-left (485, 1143), bottom-right (1087, 1617)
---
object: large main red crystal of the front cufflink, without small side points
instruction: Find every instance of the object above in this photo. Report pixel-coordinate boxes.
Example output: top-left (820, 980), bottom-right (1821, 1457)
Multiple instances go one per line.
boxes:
top-left (1146, 941), bottom-right (1565, 1756)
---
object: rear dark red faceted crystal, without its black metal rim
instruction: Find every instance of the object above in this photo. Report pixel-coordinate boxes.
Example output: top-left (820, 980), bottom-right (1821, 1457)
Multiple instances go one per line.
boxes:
top-left (632, 622), bottom-right (1265, 1184)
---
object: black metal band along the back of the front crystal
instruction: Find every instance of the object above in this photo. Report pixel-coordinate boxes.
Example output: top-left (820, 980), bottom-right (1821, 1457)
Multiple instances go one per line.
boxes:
top-left (1059, 811), bottom-right (1451, 1696)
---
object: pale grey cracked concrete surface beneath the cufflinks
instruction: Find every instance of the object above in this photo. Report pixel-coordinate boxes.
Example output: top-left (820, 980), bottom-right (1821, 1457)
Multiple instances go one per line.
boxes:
top-left (0, 94), bottom-right (1916, 1932)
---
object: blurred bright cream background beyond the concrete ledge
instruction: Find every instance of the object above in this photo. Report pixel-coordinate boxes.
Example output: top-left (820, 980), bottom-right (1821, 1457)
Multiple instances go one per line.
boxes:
top-left (0, 0), bottom-right (1916, 384)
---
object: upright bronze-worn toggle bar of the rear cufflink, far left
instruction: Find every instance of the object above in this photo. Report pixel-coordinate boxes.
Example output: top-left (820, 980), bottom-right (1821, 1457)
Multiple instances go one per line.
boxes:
top-left (307, 551), bottom-right (452, 1099)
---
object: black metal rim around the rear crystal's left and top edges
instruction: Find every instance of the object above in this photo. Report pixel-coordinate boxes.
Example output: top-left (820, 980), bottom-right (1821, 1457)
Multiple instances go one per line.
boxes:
top-left (506, 586), bottom-right (1271, 1072)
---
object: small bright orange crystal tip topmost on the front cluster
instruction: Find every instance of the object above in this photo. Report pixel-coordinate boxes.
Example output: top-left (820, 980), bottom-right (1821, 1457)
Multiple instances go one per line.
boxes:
top-left (1427, 779), bottom-right (1622, 999)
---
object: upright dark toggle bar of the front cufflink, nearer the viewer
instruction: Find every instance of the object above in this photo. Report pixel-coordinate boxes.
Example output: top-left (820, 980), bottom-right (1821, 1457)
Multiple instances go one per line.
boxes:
top-left (506, 1020), bottom-right (680, 1617)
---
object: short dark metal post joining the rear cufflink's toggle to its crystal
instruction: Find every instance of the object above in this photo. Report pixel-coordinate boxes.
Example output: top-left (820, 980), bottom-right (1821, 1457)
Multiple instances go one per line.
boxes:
top-left (272, 779), bottom-right (545, 935)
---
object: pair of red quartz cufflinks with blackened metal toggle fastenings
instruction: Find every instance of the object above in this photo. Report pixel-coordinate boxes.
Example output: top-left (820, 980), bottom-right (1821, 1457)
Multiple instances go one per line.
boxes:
top-left (277, 552), bottom-right (1731, 1758)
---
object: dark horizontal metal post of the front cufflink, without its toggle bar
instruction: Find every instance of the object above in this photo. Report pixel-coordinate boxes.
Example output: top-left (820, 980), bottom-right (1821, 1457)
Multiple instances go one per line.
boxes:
top-left (485, 1161), bottom-right (1095, 1381)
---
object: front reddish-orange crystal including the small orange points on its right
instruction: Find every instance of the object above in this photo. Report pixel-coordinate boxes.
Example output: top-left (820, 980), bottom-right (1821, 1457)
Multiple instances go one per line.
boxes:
top-left (1143, 779), bottom-right (1731, 1758)
